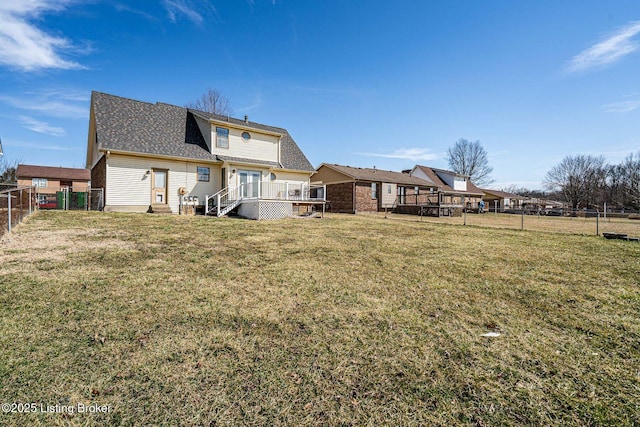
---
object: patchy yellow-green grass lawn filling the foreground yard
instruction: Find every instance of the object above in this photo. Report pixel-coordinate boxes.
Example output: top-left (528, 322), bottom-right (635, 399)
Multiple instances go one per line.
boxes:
top-left (0, 211), bottom-right (640, 426)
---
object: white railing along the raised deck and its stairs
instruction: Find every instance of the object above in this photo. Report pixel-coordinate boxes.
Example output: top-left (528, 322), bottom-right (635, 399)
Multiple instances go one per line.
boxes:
top-left (205, 182), bottom-right (327, 216)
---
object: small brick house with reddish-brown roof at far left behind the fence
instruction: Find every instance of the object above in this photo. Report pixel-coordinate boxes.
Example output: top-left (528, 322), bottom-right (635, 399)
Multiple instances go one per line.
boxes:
top-left (16, 165), bottom-right (91, 194)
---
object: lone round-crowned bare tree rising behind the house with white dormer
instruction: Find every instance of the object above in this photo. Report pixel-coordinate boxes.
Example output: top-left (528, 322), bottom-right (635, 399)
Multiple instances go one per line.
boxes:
top-left (446, 139), bottom-right (493, 187)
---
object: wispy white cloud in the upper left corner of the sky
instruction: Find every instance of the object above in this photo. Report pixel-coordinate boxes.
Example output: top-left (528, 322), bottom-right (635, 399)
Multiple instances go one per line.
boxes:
top-left (0, 0), bottom-right (84, 71)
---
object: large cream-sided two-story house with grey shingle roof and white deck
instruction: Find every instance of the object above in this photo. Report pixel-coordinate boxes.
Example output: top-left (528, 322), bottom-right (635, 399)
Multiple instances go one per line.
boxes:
top-left (87, 92), bottom-right (323, 219)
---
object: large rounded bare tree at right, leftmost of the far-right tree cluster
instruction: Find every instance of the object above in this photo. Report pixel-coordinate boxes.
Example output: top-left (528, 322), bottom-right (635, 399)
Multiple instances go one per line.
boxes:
top-left (544, 155), bottom-right (607, 209)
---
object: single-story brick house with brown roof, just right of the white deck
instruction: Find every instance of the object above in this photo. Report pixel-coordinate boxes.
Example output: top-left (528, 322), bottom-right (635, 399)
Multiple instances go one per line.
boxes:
top-left (311, 163), bottom-right (437, 213)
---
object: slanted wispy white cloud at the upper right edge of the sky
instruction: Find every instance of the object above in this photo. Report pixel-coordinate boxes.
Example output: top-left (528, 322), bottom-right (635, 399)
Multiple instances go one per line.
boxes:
top-left (567, 21), bottom-right (640, 72)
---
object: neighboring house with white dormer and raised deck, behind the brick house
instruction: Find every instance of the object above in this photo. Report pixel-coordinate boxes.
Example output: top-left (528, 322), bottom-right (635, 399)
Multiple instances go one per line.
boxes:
top-left (405, 165), bottom-right (484, 216)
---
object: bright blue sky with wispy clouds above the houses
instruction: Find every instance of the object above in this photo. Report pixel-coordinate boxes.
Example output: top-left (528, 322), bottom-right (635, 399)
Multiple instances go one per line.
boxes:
top-left (0, 0), bottom-right (640, 188)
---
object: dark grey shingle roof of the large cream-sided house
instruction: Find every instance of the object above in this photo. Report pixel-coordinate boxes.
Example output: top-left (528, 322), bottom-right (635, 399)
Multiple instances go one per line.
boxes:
top-left (91, 92), bottom-right (314, 172)
